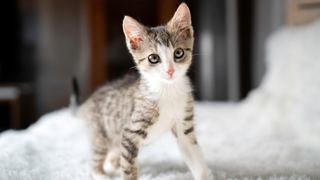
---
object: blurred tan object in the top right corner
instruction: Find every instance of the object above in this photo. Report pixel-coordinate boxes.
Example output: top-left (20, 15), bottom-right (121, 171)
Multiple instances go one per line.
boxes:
top-left (287, 0), bottom-right (320, 26)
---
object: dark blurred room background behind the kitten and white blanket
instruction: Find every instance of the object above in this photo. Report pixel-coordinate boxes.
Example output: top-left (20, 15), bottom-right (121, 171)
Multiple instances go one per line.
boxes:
top-left (0, 0), bottom-right (320, 131)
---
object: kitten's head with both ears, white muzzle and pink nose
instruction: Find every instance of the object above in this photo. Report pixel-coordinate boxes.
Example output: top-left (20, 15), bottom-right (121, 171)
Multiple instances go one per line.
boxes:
top-left (123, 3), bottom-right (193, 82)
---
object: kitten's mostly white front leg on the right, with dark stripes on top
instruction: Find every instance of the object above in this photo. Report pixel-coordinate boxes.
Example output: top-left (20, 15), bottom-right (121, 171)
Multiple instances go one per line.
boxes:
top-left (173, 112), bottom-right (209, 180)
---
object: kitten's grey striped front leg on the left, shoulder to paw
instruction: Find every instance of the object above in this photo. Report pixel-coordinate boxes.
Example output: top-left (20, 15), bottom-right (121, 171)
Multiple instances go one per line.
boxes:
top-left (120, 97), bottom-right (159, 180)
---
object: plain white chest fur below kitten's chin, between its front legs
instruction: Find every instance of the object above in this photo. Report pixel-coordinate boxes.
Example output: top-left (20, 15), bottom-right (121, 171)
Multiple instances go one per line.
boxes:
top-left (142, 77), bottom-right (191, 145)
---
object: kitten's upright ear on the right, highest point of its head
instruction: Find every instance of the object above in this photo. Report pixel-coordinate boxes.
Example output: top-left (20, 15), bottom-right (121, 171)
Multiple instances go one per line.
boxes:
top-left (168, 3), bottom-right (193, 37)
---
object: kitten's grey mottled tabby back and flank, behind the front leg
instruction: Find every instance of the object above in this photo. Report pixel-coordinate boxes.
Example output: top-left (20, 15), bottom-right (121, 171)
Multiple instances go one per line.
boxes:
top-left (81, 74), bottom-right (140, 138)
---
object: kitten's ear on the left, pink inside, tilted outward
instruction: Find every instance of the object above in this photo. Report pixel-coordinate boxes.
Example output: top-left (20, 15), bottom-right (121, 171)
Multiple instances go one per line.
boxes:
top-left (123, 16), bottom-right (146, 49)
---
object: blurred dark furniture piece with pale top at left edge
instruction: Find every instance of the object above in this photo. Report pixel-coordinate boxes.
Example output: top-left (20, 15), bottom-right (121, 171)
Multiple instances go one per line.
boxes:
top-left (0, 85), bottom-right (21, 129)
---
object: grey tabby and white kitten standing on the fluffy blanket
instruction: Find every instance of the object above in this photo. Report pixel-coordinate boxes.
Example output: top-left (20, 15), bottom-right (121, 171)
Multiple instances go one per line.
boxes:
top-left (78, 3), bottom-right (208, 180)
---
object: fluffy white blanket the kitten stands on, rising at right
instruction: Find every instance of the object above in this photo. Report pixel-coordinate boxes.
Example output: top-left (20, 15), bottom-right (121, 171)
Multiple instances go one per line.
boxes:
top-left (0, 21), bottom-right (320, 180)
